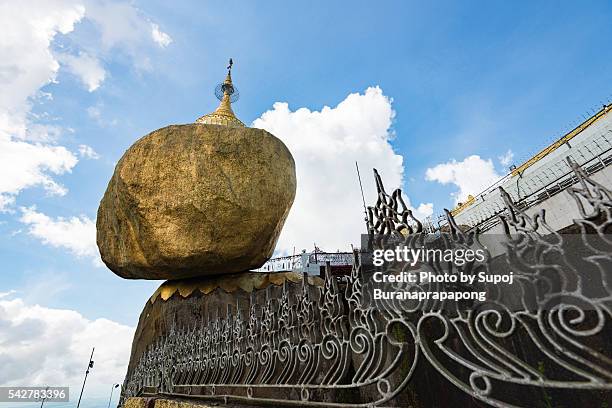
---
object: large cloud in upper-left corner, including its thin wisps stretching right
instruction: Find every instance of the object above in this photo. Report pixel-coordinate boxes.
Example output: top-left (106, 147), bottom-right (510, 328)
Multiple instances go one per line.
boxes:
top-left (0, 0), bottom-right (170, 211)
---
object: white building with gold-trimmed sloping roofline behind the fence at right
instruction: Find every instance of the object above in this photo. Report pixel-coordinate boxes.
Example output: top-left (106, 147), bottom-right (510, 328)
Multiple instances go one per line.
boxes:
top-left (444, 105), bottom-right (612, 233)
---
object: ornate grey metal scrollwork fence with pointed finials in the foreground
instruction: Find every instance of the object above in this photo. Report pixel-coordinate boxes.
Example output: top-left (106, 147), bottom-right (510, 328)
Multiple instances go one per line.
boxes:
top-left (123, 159), bottom-right (612, 407)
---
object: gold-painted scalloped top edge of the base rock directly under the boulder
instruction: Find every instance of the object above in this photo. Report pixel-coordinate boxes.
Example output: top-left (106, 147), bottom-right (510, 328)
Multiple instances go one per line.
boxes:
top-left (150, 272), bottom-right (323, 303)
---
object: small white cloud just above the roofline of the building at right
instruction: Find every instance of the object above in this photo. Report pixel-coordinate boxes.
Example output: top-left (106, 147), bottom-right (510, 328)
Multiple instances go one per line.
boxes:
top-left (425, 155), bottom-right (501, 204)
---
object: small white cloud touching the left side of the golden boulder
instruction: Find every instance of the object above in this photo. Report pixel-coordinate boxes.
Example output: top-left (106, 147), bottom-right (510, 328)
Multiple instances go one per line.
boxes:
top-left (20, 207), bottom-right (102, 266)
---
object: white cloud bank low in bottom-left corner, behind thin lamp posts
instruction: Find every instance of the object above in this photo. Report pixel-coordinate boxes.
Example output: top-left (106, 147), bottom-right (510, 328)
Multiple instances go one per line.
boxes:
top-left (0, 291), bottom-right (134, 398)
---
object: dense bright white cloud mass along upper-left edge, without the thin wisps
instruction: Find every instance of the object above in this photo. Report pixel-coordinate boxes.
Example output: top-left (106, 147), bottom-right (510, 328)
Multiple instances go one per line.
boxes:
top-left (0, 1), bottom-right (85, 214)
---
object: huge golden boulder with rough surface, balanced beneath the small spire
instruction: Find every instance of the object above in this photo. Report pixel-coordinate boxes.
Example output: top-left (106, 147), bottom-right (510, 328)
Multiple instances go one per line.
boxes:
top-left (97, 124), bottom-right (296, 279)
